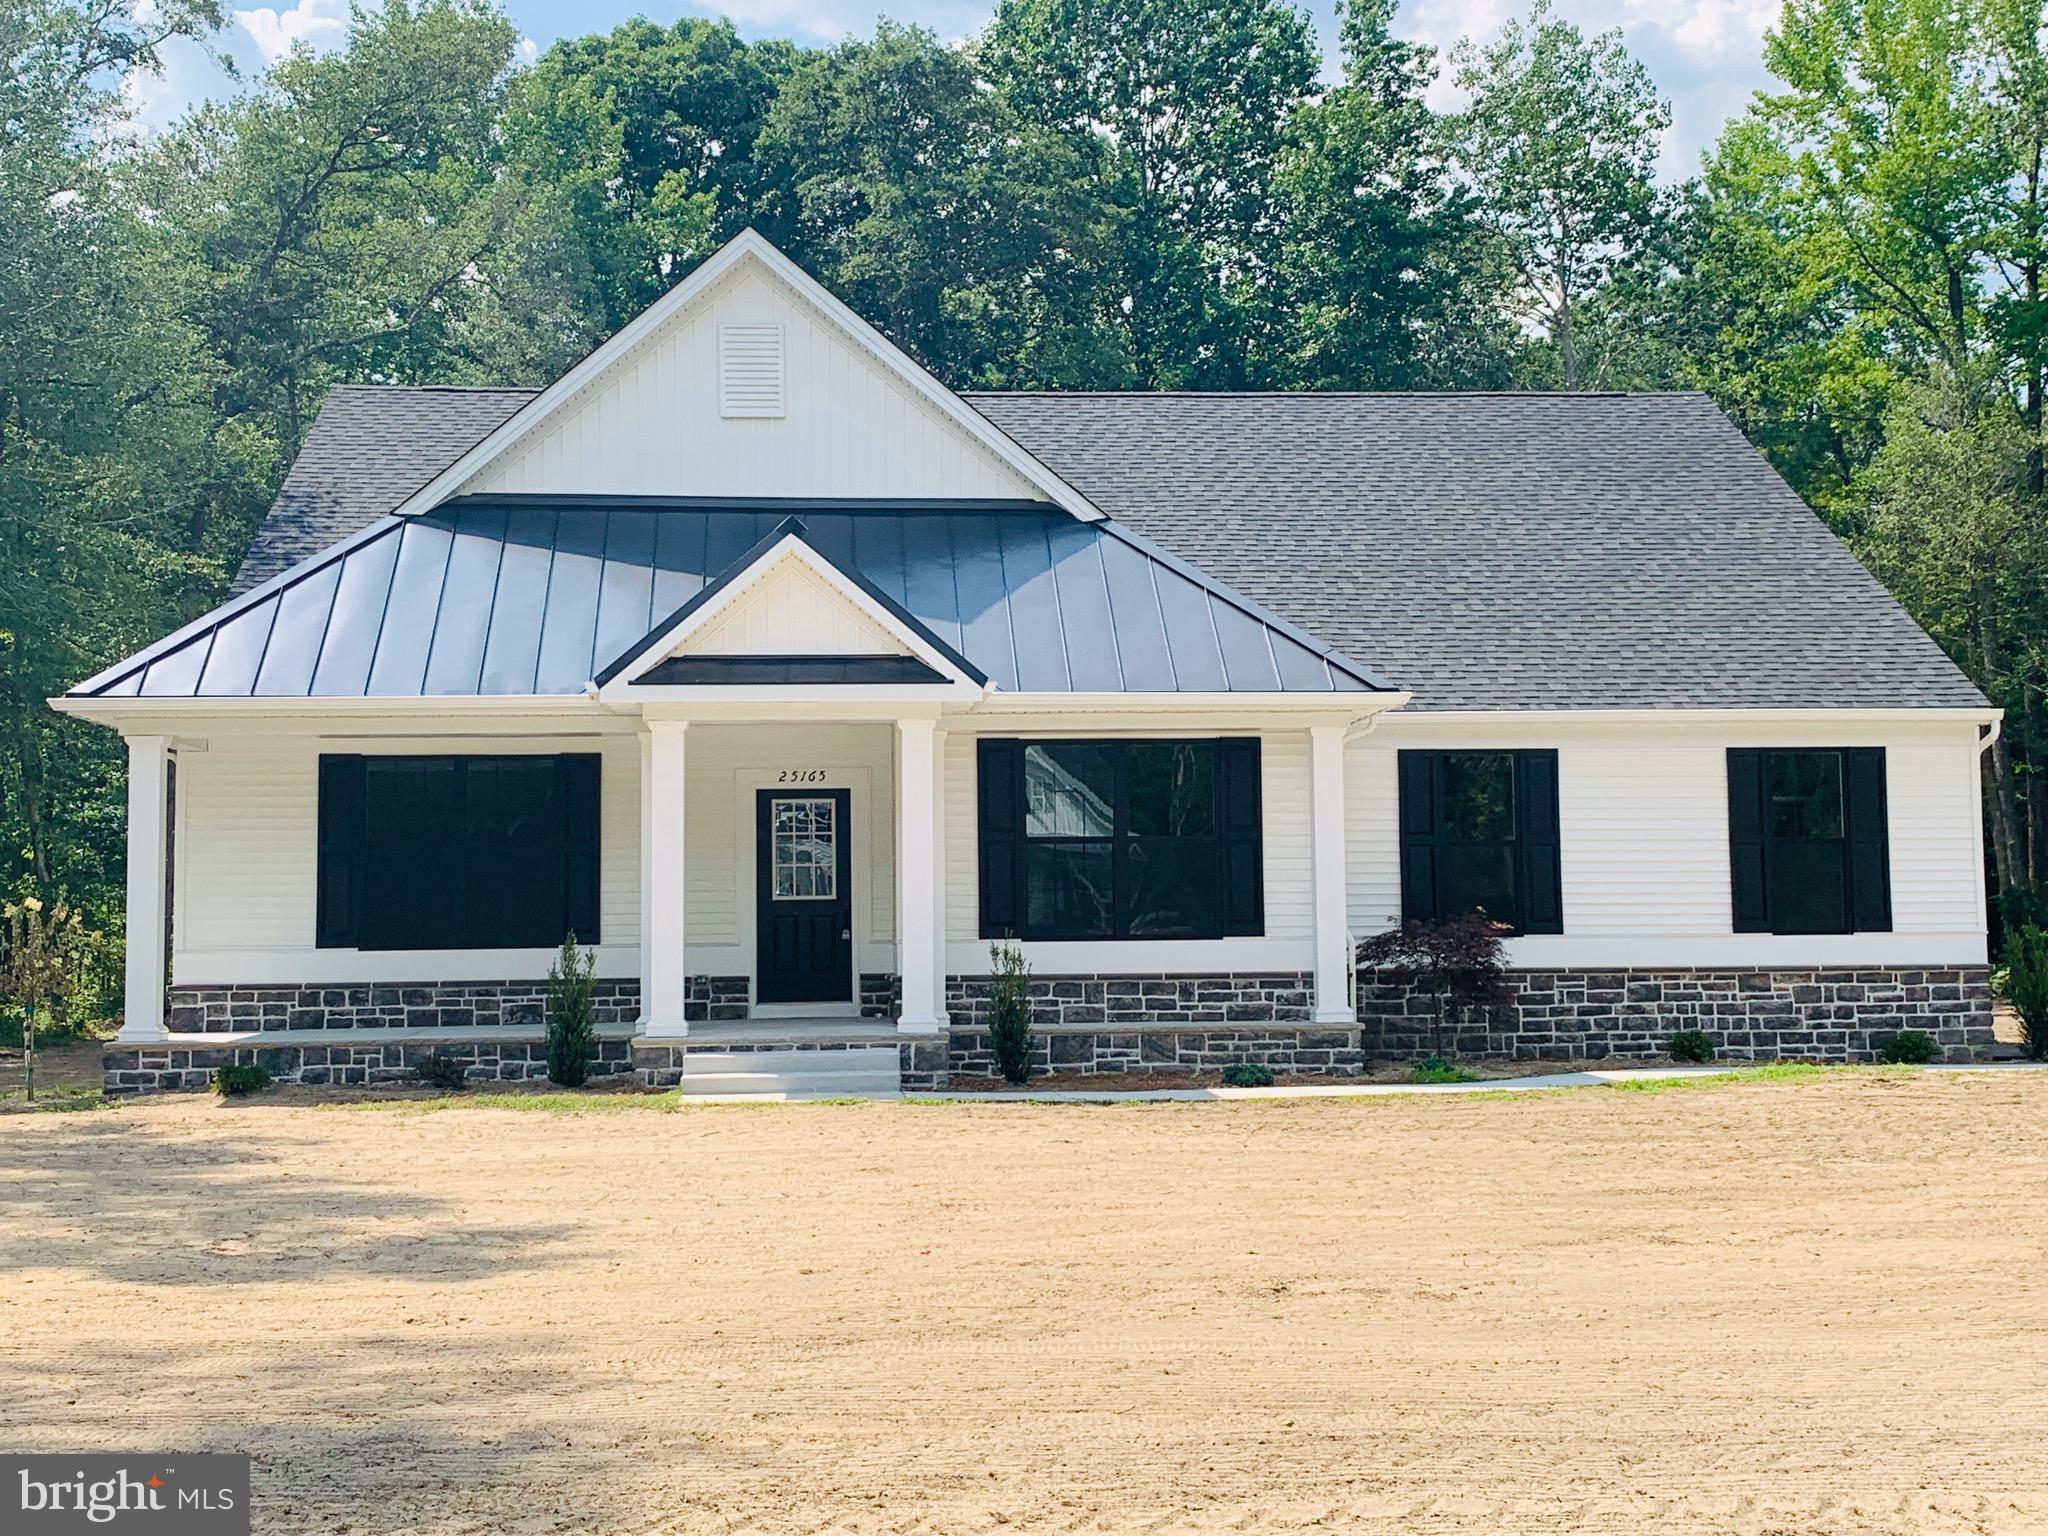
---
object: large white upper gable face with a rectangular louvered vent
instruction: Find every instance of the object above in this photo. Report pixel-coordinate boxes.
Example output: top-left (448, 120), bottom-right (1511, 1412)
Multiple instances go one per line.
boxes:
top-left (461, 262), bottom-right (1044, 500)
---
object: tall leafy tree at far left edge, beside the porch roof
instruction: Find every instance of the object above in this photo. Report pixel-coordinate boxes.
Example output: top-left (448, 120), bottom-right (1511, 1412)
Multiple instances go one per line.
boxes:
top-left (0, 0), bottom-right (233, 922)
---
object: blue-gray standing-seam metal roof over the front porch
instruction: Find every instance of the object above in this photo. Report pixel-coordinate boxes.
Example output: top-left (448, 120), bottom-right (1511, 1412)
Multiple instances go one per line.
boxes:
top-left (83, 496), bottom-right (1384, 698)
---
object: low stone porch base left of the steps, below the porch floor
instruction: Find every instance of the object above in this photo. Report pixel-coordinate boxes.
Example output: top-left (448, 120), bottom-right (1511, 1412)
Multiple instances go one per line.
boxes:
top-left (100, 1040), bottom-right (633, 1098)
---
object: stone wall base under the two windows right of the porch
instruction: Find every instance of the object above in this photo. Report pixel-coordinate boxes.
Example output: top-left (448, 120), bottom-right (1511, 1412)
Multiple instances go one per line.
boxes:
top-left (1358, 965), bottom-right (1991, 1061)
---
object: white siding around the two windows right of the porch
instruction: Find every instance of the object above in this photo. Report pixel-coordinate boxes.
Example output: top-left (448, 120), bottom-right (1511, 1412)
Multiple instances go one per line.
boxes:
top-left (1346, 715), bottom-right (1985, 969)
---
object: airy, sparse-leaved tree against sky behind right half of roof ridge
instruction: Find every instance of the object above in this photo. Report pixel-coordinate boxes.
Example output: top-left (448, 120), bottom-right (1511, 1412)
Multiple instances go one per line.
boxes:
top-left (1448, 0), bottom-right (1671, 389)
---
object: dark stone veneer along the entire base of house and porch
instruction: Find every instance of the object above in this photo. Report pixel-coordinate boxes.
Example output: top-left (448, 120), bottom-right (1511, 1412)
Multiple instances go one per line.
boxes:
top-left (104, 967), bottom-right (1993, 1094)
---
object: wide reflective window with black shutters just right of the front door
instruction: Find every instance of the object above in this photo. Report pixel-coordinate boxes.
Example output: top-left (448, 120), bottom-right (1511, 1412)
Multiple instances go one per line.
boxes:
top-left (979, 739), bottom-right (1266, 940)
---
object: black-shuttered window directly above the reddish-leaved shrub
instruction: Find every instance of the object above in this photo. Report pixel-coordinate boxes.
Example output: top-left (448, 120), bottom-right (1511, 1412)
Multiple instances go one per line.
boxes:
top-left (1399, 752), bottom-right (1565, 934)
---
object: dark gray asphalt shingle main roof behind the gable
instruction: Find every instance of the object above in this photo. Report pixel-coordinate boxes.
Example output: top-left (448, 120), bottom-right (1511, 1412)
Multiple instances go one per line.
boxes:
top-left (199, 387), bottom-right (1982, 709)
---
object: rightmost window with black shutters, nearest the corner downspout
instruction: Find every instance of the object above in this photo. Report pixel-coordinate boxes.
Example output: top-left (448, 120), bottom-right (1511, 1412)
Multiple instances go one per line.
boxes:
top-left (1729, 748), bottom-right (1892, 934)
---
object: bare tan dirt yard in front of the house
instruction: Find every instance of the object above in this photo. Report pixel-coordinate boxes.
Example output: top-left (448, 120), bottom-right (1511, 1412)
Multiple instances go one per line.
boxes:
top-left (0, 1073), bottom-right (2048, 1536)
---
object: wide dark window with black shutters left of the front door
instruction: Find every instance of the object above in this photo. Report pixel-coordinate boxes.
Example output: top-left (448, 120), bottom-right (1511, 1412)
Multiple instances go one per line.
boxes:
top-left (317, 754), bottom-right (600, 950)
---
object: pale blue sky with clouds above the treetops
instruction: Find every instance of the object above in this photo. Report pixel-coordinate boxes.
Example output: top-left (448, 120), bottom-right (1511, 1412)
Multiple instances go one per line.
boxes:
top-left (129, 0), bottom-right (1778, 178)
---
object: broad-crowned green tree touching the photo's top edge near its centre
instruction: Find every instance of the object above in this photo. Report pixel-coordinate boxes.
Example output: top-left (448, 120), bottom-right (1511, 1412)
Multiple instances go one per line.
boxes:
top-left (981, 0), bottom-right (1315, 389)
